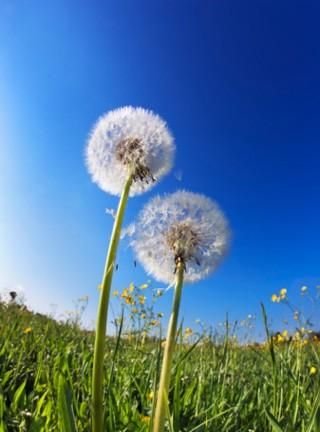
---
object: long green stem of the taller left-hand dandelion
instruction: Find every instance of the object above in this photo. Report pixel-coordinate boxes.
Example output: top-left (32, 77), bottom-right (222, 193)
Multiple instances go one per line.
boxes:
top-left (92, 176), bottom-right (132, 432)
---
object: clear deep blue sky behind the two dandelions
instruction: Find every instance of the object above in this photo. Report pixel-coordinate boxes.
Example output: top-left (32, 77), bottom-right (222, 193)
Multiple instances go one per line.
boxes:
top-left (0, 0), bottom-right (320, 336)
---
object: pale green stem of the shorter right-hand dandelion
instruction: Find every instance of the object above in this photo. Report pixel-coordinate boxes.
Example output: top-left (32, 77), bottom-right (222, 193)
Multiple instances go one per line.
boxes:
top-left (153, 262), bottom-right (184, 432)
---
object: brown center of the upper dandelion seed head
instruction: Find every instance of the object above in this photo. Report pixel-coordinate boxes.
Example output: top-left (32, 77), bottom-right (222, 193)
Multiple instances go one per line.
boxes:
top-left (116, 138), bottom-right (155, 183)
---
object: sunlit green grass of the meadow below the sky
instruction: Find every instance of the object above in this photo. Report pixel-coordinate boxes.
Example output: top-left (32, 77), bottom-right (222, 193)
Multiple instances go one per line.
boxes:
top-left (0, 303), bottom-right (320, 432)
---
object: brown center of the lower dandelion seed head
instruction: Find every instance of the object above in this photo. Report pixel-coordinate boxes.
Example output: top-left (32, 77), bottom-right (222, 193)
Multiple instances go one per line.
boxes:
top-left (166, 221), bottom-right (201, 264)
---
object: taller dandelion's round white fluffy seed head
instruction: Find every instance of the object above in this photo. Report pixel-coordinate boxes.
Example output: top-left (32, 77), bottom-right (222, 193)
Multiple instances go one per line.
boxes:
top-left (86, 106), bottom-right (175, 196)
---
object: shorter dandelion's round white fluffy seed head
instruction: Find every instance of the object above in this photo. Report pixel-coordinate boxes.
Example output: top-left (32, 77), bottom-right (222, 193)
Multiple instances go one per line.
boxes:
top-left (132, 191), bottom-right (230, 283)
